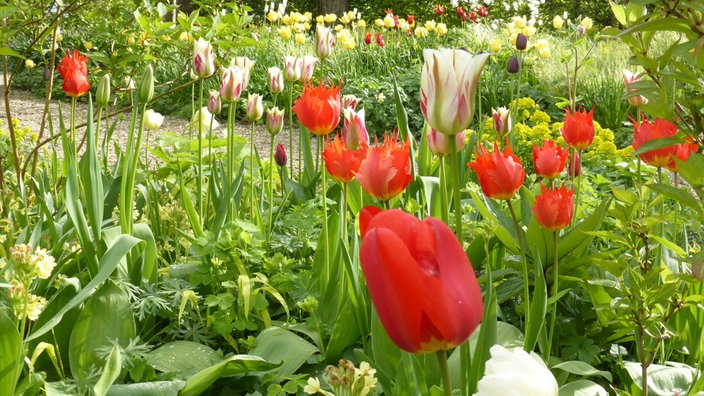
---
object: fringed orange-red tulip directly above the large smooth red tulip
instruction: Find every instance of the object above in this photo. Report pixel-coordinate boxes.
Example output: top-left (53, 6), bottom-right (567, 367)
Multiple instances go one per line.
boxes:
top-left (356, 134), bottom-right (412, 201)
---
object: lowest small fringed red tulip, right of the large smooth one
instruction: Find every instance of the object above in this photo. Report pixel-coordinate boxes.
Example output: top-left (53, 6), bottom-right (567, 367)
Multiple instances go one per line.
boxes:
top-left (533, 184), bottom-right (574, 231)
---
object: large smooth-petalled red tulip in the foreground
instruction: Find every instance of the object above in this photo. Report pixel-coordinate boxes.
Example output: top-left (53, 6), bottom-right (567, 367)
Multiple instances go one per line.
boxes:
top-left (360, 210), bottom-right (483, 353)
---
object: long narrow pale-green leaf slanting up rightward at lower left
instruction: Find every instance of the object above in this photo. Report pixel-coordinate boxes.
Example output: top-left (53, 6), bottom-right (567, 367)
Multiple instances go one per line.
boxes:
top-left (25, 235), bottom-right (144, 342)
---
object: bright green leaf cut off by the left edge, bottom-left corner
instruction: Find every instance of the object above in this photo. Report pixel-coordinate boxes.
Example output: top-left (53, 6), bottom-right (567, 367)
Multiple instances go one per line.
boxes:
top-left (0, 312), bottom-right (24, 395)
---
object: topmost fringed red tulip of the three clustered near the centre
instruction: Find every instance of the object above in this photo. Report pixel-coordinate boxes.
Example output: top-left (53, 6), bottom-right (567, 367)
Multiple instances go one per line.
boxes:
top-left (293, 83), bottom-right (342, 136)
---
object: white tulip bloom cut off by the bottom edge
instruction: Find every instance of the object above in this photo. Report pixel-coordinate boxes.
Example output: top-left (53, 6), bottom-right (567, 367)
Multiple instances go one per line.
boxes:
top-left (474, 345), bottom-right (559, 396)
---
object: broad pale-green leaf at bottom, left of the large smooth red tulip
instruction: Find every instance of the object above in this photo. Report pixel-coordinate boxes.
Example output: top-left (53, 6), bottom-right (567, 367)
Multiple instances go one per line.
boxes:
top-left (249, 327), bottom-right (318, 378)
